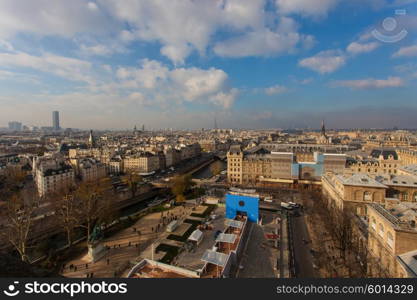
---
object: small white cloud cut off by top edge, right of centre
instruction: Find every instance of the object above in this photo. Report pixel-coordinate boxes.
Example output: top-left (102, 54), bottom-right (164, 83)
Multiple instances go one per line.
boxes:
top-left (275, 0), bottom-right (338, 17)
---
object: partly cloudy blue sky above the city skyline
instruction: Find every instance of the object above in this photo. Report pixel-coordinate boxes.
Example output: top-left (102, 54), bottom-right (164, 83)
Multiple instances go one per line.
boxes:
top-left (0, 0), bottom-right (417, 129)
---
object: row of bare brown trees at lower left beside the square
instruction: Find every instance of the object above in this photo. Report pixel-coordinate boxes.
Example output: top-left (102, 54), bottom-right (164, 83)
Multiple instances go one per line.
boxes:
top-left (0, 171), bottom-right (117, 261)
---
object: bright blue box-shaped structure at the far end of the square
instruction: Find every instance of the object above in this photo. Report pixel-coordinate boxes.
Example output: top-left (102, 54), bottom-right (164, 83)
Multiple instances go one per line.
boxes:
top-left (226, 193), bottom-right (259, 223)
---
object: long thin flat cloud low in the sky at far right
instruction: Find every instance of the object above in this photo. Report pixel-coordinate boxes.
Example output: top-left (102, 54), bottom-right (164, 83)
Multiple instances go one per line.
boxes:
top-left (332, 77), bottom-right (405, 90)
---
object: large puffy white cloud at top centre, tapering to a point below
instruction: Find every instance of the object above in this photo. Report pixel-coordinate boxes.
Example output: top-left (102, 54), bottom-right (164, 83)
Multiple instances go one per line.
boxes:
top-left (99, 0), bottom-right (266, 64)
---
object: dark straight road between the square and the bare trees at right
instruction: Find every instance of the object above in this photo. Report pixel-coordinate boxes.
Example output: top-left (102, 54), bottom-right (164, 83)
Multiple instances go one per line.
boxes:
top-left (290, 215), bottom-right (316, 278)
